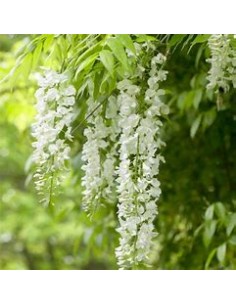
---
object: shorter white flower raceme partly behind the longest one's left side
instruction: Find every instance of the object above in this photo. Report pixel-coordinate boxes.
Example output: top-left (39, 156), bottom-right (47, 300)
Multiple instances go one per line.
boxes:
top-left (82, 96), bottom-right (121, 216)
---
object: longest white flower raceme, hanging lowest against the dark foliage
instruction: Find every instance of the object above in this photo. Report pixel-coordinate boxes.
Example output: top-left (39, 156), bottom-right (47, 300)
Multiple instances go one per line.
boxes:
top-left (116, 54), bottom-right (167, 268)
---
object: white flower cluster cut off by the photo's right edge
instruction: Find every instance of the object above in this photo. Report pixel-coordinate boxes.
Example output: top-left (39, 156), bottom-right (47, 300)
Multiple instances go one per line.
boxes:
top-left (207, 34), bottom-right (236, 92)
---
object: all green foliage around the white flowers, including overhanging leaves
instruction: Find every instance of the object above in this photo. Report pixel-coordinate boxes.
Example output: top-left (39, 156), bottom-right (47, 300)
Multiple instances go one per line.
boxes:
top-left (0, 34), bottom-right (236, 269)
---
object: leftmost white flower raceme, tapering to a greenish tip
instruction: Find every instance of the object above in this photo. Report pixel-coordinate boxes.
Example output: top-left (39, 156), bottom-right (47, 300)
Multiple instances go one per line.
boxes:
top-left (32, 70), bottom-right (76, 206)
